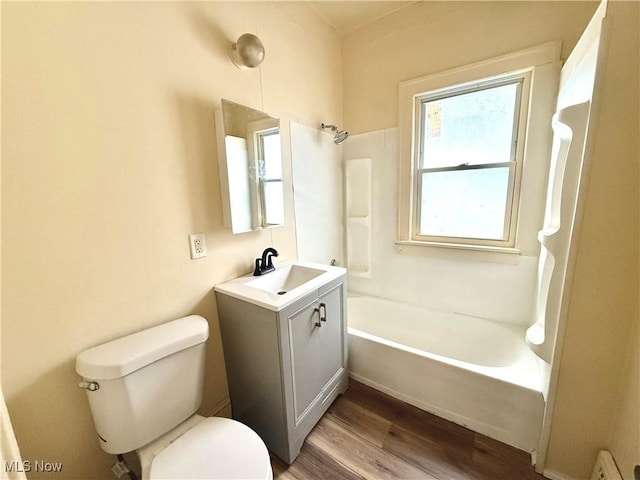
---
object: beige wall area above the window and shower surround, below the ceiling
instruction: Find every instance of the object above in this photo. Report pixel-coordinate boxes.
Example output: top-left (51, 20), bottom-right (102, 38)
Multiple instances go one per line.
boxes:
top-left (343, 1), bottom-right (597, 133)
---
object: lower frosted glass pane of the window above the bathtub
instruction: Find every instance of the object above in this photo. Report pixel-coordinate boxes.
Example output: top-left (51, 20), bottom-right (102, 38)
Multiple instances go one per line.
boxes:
top-left (418, 167), bottom-right (510, 240)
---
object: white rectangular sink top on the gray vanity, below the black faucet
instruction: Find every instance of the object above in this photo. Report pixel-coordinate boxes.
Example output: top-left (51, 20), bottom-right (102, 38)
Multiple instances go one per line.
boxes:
top-left (215, 262), bottom-right (346, 311)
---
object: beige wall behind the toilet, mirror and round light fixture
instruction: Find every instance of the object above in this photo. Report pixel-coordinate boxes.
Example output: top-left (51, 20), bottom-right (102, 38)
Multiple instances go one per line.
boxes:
top-left (2, 2), bottom-right (342, 478)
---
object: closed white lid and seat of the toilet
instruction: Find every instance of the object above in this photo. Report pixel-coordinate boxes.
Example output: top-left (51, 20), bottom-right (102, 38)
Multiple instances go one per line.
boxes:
top-left (149, 417), bottom-right (273, 480)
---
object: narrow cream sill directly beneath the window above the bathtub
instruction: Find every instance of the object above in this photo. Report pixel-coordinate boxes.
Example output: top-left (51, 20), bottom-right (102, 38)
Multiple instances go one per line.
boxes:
top-left (395, 240), bottom-right (521, 265)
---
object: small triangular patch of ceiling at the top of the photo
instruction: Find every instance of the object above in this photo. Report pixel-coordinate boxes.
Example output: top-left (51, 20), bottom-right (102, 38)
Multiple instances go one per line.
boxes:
top-left (308, 0), bottom-right (416, 34)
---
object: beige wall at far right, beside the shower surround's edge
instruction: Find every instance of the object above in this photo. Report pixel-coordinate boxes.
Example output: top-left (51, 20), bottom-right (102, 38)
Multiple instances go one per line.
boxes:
top-left (547, 2), bottom-right (640, 478)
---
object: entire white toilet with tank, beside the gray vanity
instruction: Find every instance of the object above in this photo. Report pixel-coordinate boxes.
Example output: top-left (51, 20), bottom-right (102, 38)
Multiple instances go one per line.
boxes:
top-left (76, 315), bottom-right (273, 480)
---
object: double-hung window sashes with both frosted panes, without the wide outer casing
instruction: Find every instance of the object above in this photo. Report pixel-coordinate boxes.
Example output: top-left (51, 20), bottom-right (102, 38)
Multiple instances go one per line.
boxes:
top-left (414, 75), bottom-right (528, 246)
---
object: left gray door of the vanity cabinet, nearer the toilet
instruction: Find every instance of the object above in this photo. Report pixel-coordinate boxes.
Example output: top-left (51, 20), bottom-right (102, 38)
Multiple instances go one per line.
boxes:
top-left (287, 301), bottom-right (324, 425)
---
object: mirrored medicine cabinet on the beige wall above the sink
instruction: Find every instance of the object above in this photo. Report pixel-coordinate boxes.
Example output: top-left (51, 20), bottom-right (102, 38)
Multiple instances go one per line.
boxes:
top-left (216, 99), bottom-right (284, 233)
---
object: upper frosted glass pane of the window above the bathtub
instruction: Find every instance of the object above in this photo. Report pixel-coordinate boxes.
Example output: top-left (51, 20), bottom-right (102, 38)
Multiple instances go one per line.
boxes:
top-left (420, 82), bottom-right (520, 168)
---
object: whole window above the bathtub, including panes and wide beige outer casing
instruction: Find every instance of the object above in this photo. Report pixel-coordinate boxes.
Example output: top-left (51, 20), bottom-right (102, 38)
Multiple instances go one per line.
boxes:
top-left (398, 44), bottom-right (559, 252)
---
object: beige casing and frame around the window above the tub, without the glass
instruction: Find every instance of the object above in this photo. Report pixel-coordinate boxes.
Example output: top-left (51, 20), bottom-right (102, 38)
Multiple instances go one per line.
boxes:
top-left (396, 42), bottom-right (561, 261)
